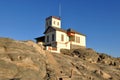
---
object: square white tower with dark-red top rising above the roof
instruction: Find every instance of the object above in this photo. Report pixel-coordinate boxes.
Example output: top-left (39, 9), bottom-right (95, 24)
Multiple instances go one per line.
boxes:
top-left (45, 16), bottom-right (61, 30)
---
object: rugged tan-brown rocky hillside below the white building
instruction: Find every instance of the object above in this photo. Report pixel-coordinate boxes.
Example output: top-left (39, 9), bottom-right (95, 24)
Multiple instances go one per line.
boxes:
top-left (0, 38), bottom-right (120, 80)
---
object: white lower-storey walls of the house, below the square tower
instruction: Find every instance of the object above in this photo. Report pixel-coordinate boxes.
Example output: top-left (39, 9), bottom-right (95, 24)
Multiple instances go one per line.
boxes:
top-left (45, 31), bottom-right (86, 52)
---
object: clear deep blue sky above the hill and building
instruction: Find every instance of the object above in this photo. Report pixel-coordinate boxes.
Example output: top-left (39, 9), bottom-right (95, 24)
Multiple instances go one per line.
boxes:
top-left (0, 0), bottom-right (120, 57)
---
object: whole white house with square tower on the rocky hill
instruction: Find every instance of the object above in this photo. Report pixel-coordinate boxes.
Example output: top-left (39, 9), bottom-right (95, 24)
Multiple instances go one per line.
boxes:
top-left (36, 16), bottom-right (86, 53)
